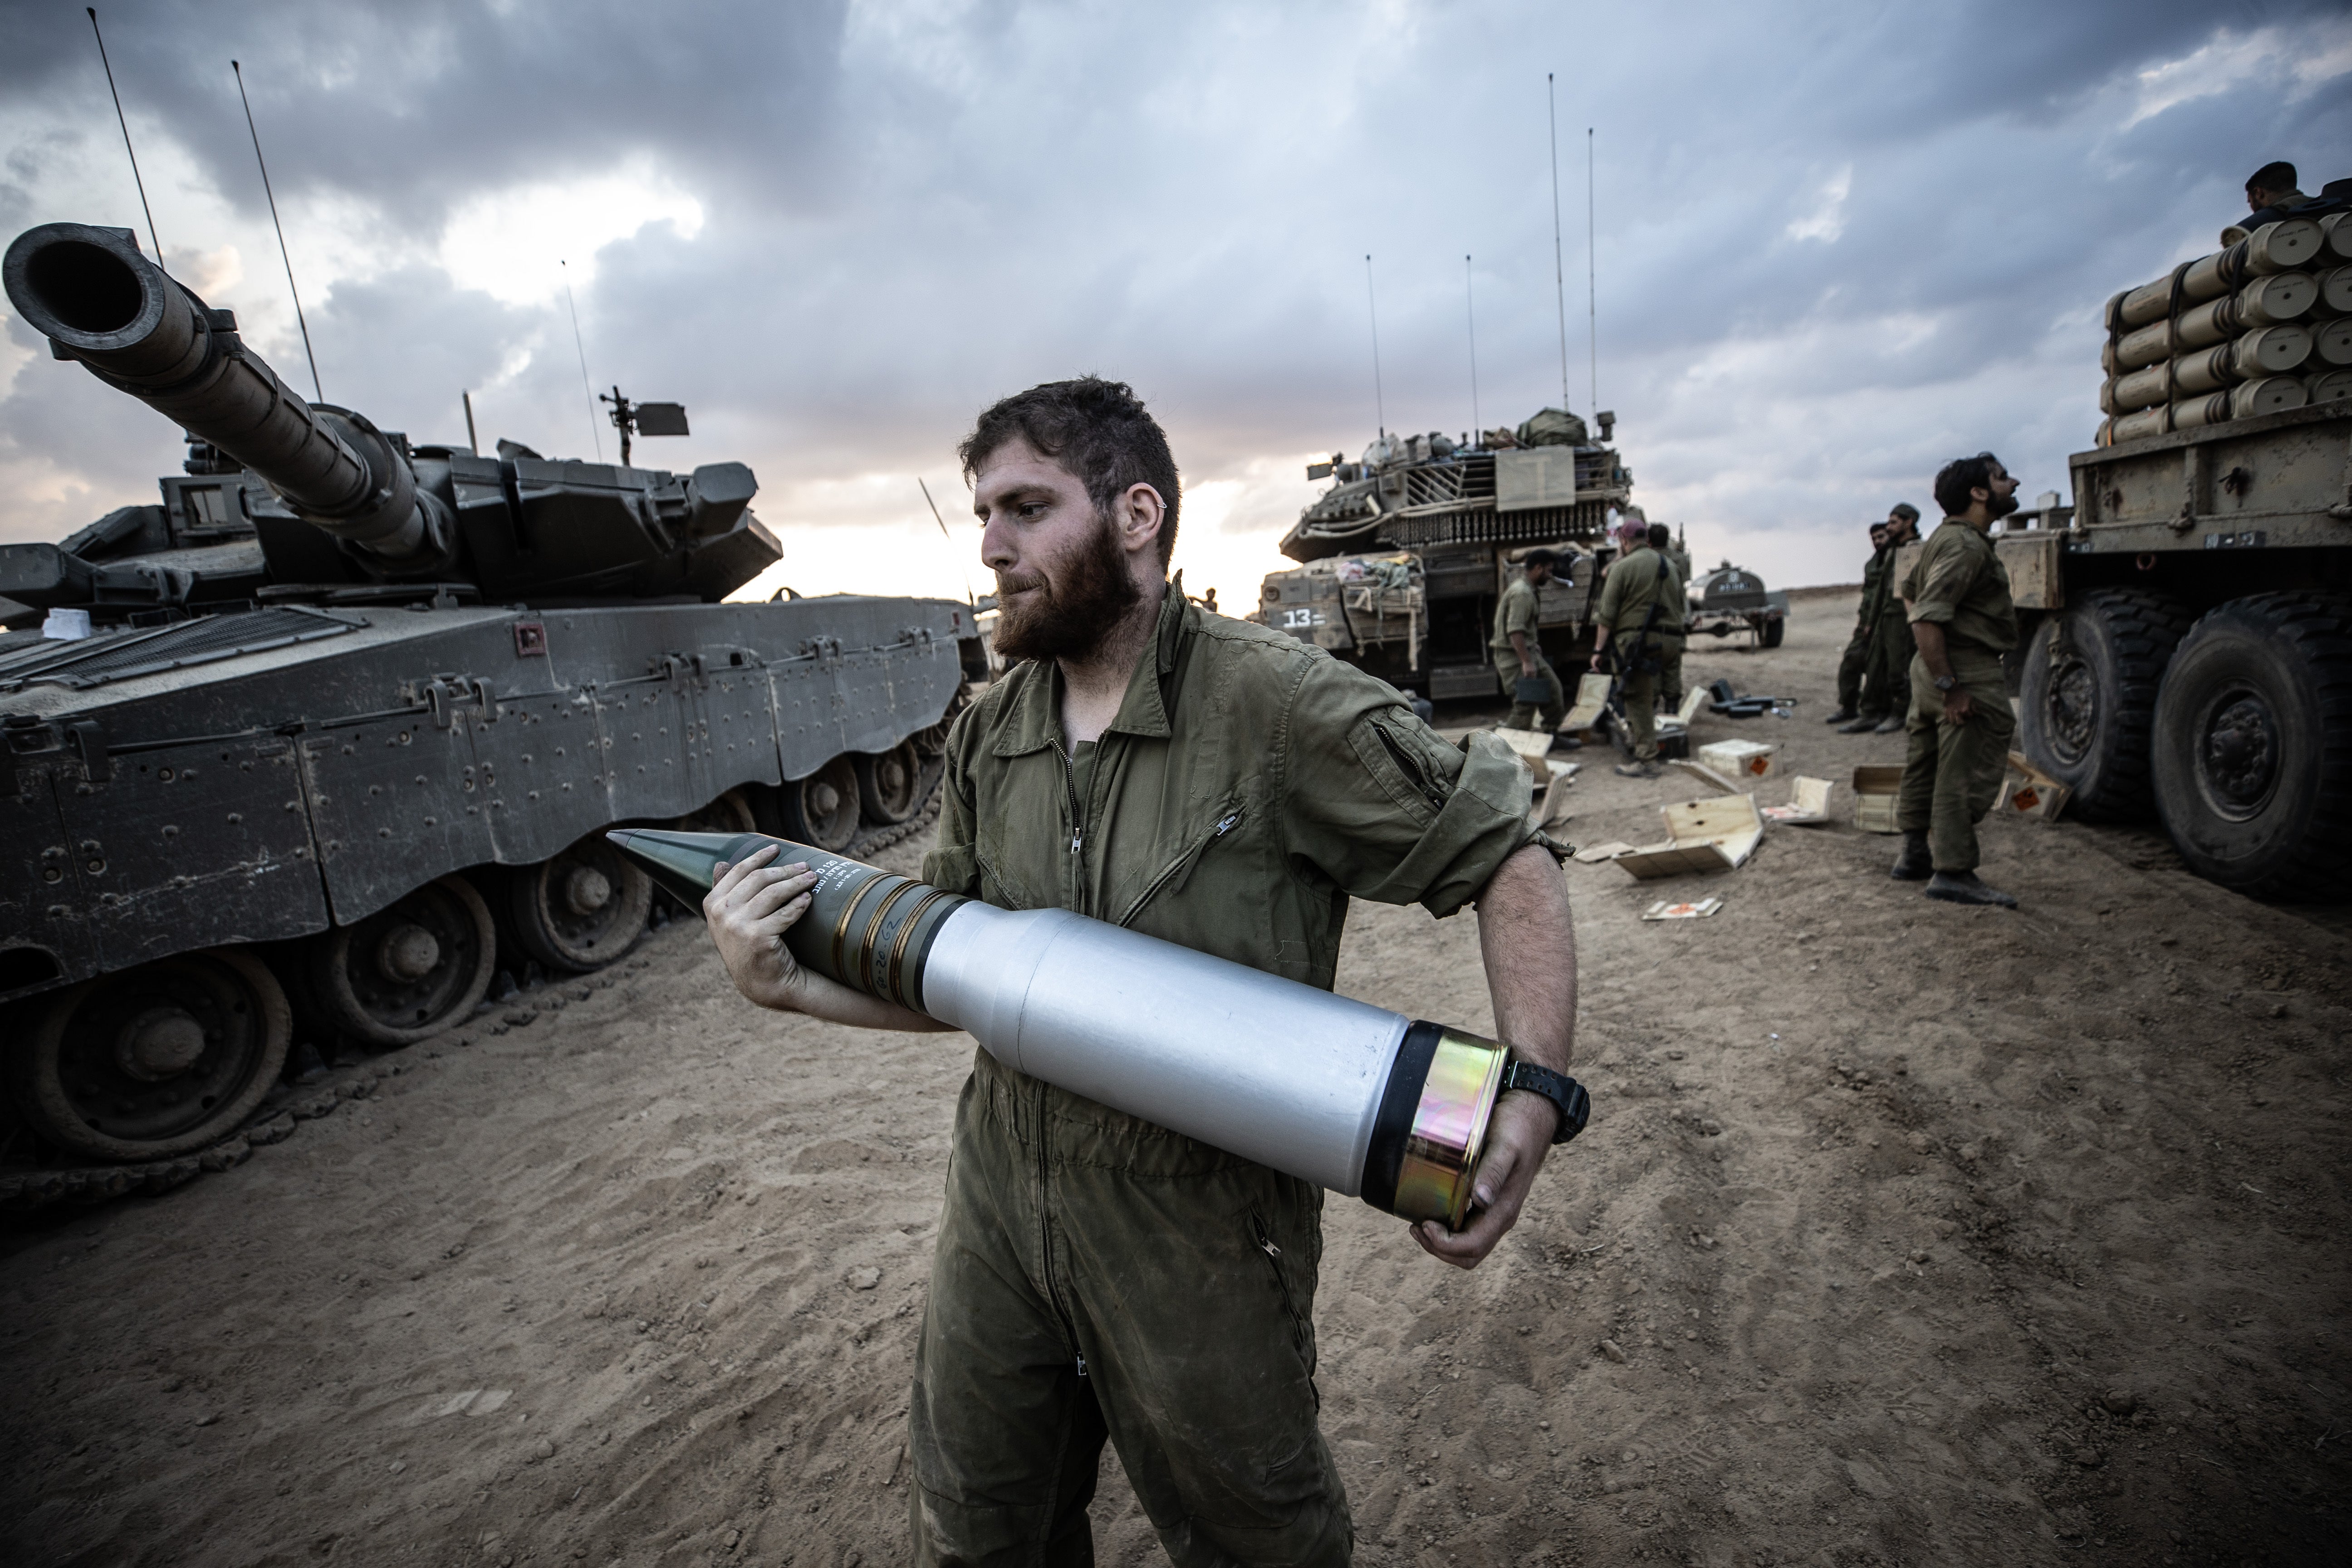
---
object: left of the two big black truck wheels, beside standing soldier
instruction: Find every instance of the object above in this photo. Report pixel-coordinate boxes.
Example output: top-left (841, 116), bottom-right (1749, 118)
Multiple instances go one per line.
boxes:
top-left (2018, 588), bottom-right (2190, 823)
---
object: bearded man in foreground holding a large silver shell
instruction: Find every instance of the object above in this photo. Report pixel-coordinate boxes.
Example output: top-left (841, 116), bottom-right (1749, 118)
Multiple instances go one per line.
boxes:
top-left (703, 376), bottom-right (1576, 1568)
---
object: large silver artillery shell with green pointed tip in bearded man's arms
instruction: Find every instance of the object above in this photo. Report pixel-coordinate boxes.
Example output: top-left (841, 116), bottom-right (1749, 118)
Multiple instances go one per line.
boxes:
top-left (604, 828), bottom-right (1508, 1230)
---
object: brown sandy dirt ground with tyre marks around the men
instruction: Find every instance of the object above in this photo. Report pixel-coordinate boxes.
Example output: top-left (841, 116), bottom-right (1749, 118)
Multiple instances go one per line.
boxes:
top-left (0, 597), bottom-right (2352, 1568)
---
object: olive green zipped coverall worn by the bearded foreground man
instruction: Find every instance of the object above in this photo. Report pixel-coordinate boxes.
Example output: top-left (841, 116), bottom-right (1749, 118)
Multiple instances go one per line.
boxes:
top-left (908, 583), bottom-right (1541, 1568)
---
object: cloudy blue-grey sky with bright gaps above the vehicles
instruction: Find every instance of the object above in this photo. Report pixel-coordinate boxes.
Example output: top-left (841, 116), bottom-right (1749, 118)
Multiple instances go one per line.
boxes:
top-left (0, 0), bottom-right (2352, 607)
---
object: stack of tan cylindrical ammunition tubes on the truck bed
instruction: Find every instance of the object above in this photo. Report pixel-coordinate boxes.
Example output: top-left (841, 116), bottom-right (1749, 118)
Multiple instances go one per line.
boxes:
top-left (2098, 211), bottom-right (2352, 446)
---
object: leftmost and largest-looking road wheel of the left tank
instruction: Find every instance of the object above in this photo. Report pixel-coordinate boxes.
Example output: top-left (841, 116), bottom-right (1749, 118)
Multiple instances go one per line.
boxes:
top-left (7, 947), bottom-right (294, 1159)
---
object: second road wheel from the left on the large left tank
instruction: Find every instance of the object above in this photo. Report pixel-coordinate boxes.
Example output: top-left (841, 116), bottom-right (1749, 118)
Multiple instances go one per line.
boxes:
top-left (310, 877), bottom-right (499, 1046)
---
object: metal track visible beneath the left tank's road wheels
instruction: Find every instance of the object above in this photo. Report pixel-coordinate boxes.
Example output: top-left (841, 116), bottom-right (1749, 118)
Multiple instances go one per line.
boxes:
top-left (0, 785), bottom-right (941, 1215)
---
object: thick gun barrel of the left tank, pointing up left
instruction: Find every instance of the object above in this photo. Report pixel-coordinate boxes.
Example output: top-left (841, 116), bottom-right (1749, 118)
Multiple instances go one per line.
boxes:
top-left (0, 223), bottom-right (456, 576)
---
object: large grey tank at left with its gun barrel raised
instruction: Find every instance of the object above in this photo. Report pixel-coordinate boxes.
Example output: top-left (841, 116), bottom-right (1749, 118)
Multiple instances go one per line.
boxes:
top-left (0, 223), bottom-right (985, 1190)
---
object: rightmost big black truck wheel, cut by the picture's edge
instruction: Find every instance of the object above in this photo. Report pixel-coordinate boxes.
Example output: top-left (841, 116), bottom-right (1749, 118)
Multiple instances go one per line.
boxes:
top-left (2155, 593), bottom-right (2352, 898)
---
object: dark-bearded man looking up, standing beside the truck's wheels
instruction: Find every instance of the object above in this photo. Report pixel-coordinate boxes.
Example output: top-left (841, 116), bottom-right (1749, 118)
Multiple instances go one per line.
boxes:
top-left (1893, 451), bottom-right (2018, 910)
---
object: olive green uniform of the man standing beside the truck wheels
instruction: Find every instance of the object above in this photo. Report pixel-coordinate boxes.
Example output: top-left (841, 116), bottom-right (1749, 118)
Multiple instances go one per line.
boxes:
top-left (1896, 517), bottom-right (2018, 872)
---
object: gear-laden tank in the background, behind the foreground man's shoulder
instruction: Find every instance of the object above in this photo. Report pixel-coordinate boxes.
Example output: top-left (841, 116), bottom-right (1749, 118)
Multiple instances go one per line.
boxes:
top-left (1251, 409), bottom-right (1632, 701)
